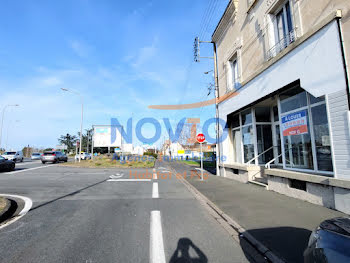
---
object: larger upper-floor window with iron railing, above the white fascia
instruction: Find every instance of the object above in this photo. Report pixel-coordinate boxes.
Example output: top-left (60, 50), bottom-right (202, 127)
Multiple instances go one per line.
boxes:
top-left (268, 1), bottom-right (296, 59)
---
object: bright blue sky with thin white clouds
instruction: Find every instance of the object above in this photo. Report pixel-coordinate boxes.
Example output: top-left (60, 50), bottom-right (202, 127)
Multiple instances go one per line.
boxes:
top-left (0, 0), bottom-right (228, 150)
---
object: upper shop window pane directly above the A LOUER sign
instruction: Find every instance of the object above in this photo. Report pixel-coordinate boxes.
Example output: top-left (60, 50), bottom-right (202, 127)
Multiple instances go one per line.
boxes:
top-left (280, 87), bottom-right (307, 113)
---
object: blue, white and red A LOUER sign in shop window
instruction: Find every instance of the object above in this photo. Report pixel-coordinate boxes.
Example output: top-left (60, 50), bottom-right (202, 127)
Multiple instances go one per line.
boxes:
top-left (282, 110), bottom-right (308, 136)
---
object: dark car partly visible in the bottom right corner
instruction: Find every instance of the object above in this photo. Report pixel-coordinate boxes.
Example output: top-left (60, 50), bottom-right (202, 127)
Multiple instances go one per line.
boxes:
top-left (304, 217), bottom-right (350, 263)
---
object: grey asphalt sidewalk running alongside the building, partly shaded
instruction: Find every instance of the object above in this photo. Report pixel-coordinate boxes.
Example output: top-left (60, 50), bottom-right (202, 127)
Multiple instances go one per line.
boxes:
top-left (170, 162), bottom-right (346, 262)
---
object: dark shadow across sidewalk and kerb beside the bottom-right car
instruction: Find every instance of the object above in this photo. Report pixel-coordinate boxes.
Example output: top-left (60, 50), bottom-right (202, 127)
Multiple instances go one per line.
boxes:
top-left (240, 227), bottom-right (311, 262)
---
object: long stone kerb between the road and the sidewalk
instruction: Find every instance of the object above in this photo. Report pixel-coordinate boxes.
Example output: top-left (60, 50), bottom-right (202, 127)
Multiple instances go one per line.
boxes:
top-left (171, 167), bottom-right (285, 263)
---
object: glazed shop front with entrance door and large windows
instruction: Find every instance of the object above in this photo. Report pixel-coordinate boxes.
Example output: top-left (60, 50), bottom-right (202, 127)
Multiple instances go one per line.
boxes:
top-left (227, 81), bottom-right (333, 176)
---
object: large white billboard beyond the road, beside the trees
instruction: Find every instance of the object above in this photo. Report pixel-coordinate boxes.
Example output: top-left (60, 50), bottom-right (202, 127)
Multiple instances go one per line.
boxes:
top-left (93, 125), bottom-right (122, 147)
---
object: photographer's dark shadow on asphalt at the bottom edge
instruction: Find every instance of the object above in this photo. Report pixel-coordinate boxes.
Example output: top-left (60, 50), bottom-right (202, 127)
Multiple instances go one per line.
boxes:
top-left (169, 237), bottom-right (208, 263)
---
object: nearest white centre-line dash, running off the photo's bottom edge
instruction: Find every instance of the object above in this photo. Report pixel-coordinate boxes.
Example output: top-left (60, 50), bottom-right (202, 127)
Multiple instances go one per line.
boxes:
top-left (150, 210), bottom-right (165, 263)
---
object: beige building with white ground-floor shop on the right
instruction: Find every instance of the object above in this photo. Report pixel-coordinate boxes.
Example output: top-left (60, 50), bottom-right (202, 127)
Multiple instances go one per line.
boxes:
top-left (212, 0), bottom-right (350, 213)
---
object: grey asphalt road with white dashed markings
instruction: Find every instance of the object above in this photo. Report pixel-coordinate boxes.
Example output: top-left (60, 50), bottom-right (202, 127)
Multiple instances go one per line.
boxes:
top-left (0, 161), bottom-right (260, 263)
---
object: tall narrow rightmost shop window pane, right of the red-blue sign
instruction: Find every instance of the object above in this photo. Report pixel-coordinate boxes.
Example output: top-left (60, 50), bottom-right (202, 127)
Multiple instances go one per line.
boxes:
top-left (311, 104), bottom-right (333, 172)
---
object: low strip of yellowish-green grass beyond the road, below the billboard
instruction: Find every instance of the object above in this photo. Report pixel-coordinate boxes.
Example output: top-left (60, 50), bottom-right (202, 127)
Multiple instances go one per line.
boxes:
top-left (61, 156), bottom-right (155, 168)
